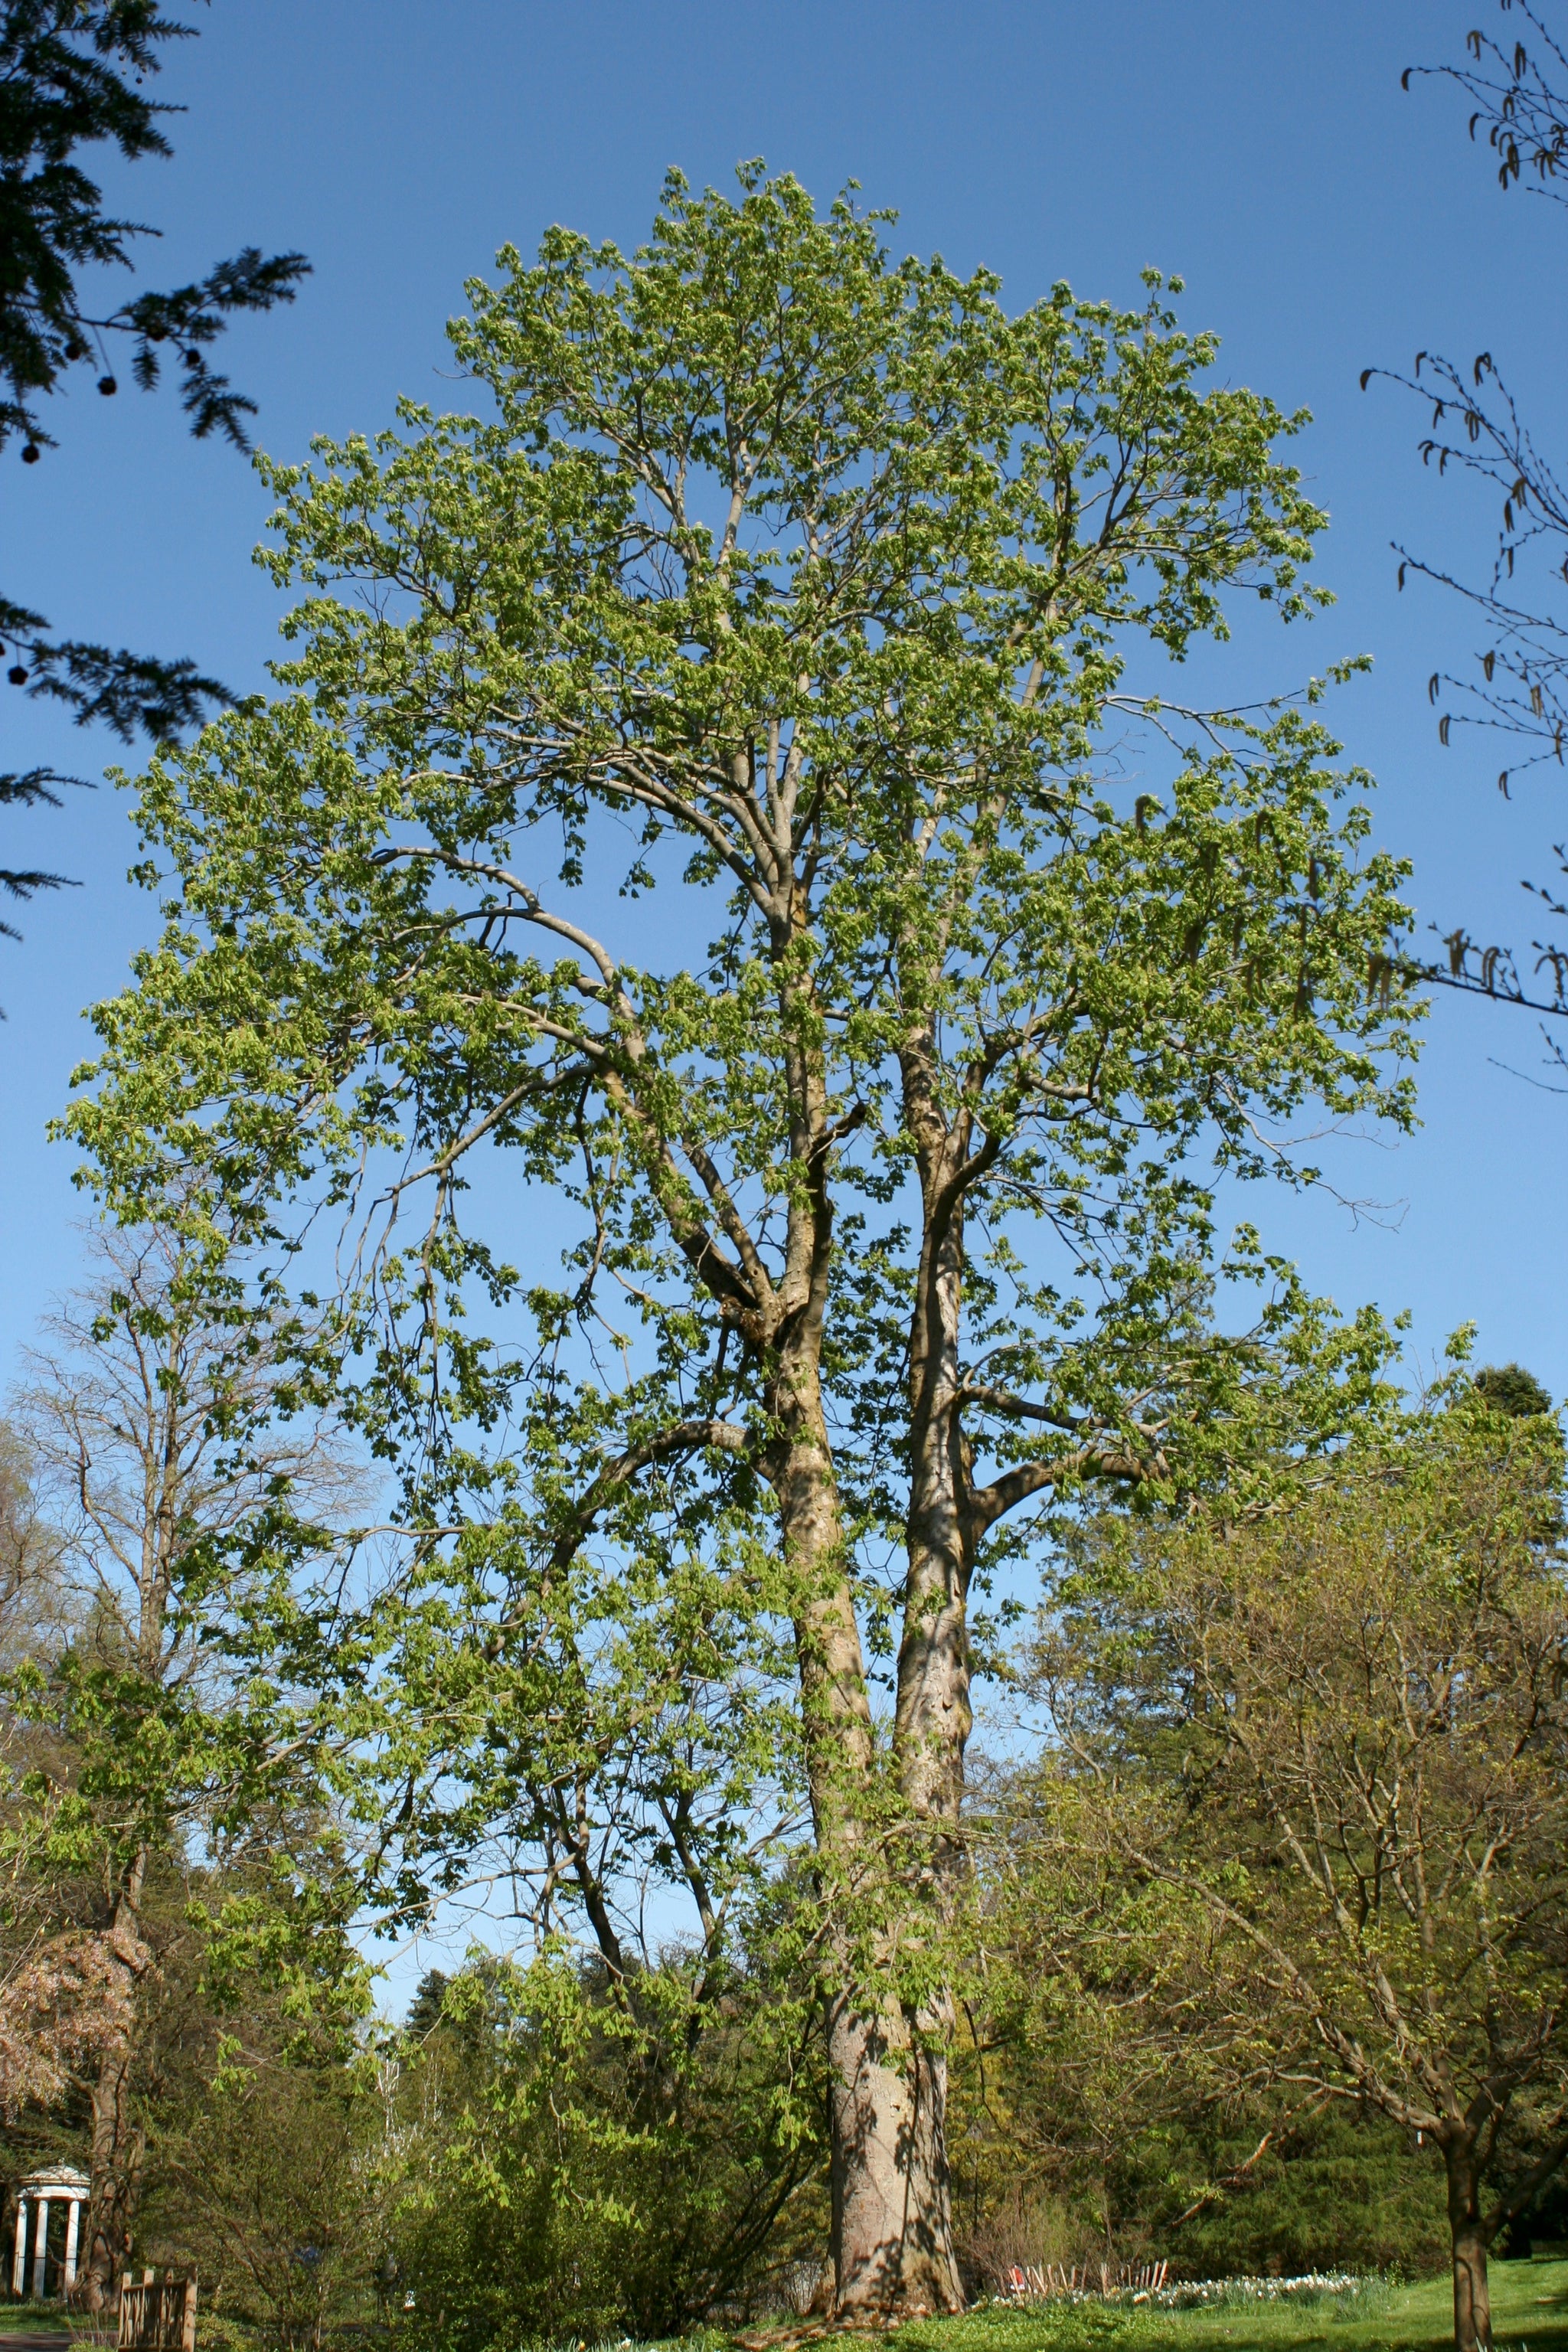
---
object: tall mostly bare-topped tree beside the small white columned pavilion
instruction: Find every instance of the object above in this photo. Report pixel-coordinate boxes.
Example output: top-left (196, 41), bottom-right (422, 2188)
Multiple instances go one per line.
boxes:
top-left (9, 1233), bottom-right (350, 2308)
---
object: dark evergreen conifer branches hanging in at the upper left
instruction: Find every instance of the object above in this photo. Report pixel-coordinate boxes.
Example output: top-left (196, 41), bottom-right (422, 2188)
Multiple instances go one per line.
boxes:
top-left (0, 0), bottom-right (308, 932)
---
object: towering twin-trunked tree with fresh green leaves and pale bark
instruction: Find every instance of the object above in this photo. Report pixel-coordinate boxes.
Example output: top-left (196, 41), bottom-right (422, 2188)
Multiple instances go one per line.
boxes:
top-left (73, 167), bottom-right (1408, 2312)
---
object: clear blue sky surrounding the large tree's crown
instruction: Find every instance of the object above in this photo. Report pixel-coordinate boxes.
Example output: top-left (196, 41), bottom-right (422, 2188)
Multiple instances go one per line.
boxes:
top-left (0, 0), bottom-right (1568, 1397)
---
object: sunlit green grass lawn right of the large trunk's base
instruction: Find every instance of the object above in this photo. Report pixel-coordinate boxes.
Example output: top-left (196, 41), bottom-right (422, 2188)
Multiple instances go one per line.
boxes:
top-left (898, 2262), bottom-right (1568, 2352)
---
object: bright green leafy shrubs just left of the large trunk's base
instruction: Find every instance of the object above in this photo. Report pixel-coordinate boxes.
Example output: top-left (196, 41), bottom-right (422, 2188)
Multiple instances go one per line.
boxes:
top-left (390, 1938), bottom-right (828, 2352)
